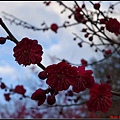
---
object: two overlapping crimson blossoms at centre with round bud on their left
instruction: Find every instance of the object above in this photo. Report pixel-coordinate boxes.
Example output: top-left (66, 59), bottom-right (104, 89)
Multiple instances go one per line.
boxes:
top-left (38, 62), bottom-right (95, 93)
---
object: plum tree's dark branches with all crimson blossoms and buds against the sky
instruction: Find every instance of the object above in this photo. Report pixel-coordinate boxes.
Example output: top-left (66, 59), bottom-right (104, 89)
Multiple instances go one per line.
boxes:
top-left (0, 1), bottom-right (120, 118)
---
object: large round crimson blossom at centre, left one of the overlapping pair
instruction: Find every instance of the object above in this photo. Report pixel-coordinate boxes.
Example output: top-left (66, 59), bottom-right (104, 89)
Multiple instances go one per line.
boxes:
top-left (46, 62), bottom-right (77, 91)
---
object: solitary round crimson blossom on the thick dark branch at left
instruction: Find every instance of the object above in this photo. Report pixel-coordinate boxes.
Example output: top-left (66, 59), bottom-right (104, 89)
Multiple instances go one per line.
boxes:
top-left (13, 37), bottom-right (43, 66)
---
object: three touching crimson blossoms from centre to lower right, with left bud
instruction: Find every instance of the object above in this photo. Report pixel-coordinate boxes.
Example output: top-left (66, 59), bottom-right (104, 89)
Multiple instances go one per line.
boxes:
top-left (37, 62), bottom-right (112, 112)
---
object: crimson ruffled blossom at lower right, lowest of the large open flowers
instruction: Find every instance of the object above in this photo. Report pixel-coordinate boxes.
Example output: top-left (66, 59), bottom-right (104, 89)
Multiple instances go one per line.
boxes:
top-left (87, 83), bottom-right (112, 112)
